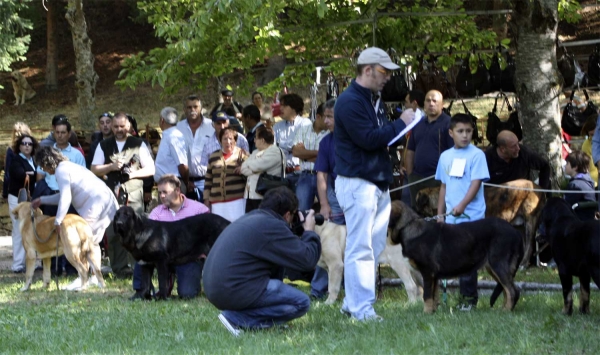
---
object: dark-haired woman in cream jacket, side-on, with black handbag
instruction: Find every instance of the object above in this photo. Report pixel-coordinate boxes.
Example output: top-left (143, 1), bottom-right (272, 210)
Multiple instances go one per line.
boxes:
top-left (242, 126), bottom-right (285, 213)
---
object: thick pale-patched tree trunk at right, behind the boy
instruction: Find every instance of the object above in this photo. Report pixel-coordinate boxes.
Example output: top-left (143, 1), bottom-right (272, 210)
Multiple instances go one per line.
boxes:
top-left (511, 0), bottom-right (562, 188)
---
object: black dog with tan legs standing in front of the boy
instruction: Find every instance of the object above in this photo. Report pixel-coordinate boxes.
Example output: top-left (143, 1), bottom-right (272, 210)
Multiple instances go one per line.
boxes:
top-left (390, 201), bottom-right (523, 313)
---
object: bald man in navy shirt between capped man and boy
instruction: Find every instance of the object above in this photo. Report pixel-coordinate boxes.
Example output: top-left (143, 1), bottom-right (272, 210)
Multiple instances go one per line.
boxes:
top-left (404, 90), bottom-right (454, 207)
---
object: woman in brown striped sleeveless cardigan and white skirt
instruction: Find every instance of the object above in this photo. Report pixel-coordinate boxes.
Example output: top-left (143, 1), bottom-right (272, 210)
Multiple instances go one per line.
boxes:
top-left (204, 127), bottom-right (248, 222)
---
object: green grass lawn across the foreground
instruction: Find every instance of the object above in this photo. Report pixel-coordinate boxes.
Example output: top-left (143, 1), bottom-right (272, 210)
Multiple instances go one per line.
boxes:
top-left (0, 269), bottom-right (600, 354)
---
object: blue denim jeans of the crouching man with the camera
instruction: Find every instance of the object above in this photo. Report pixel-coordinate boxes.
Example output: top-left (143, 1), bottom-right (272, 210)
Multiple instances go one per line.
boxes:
top-left (221, 279), bottom-right (310, 329)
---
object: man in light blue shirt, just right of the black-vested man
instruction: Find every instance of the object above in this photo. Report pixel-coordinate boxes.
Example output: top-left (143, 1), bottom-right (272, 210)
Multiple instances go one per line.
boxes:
top-left (154, 107), bottom-right (189, 193)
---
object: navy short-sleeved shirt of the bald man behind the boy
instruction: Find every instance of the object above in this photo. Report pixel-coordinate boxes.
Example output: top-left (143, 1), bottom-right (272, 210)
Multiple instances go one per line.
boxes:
top-left (408, 113), bottom-right (454, 176)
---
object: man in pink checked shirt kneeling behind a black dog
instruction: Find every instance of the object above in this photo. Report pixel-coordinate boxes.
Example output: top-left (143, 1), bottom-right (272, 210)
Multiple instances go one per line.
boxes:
top-left (133, 174), bottom-right (209, 298)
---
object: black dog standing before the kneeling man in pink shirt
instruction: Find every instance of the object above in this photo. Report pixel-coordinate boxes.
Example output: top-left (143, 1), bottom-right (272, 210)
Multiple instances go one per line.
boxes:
top-left (113, 206), bottom-right (229, 299)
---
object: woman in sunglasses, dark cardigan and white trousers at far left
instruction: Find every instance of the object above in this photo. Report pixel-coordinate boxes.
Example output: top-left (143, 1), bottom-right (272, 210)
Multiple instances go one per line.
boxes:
top-left (8, 134), bottom-right (38, 273)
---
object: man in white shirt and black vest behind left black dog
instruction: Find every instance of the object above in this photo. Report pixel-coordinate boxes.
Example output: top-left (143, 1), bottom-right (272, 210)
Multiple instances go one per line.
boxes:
top-left (91, 112), bottom-right (155, 277)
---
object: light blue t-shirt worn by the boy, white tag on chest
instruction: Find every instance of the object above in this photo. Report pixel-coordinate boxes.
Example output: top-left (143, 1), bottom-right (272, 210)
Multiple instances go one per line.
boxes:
top-left (435, 144), bottom-right (490, 224)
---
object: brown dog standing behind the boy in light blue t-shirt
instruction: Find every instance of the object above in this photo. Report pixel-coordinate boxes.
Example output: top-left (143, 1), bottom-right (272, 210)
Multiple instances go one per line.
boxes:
top-left (415, 179), bottom-right (546, 266)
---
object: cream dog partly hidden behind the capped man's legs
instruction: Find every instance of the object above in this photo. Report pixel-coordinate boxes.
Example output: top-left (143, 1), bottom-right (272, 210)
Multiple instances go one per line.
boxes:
top-left (315, 221), bottom-right (420, 304)
